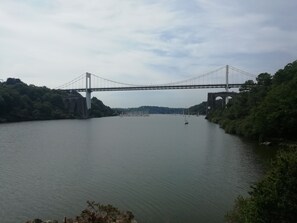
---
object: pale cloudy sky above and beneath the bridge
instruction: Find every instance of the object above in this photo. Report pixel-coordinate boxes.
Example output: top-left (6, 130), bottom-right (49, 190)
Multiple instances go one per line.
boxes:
top-left (0, 0), bottom-right (297, 107)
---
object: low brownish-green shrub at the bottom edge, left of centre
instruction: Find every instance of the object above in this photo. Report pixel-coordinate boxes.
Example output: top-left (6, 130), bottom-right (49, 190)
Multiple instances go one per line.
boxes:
top-left (26, 201), bottom-right (137, 223)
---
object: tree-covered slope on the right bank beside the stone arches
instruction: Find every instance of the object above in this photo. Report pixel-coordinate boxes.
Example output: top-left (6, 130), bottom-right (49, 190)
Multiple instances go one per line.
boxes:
top-left (209, 61), bottom-right (297, 140)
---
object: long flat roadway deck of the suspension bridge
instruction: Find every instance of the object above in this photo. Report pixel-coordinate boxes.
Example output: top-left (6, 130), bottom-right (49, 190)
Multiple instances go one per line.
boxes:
top-left (63, 84), bottom-right (243, 92)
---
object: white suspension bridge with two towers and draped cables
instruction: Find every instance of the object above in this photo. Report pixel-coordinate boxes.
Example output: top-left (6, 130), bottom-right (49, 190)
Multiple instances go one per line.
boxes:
top-left (56, 65), bottom-right (256, 109)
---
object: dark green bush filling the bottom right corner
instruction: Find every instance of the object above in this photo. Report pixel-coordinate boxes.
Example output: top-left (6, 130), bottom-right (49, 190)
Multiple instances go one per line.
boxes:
top-left (226, 148), bottom-right (297, 223)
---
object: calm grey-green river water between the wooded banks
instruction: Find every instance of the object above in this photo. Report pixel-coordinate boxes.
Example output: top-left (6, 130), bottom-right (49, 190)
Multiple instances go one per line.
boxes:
top-left (0, 115), bottom-right (267, 223)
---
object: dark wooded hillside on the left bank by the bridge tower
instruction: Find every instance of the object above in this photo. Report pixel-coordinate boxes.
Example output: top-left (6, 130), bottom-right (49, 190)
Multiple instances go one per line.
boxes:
top-left (0, 78), bottom-right (114, 123)
